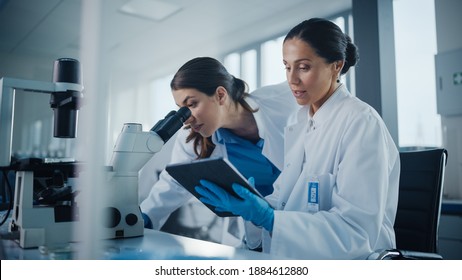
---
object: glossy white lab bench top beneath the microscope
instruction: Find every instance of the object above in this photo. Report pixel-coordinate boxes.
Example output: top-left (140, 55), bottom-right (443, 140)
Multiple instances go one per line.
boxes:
top-left (1, 225), bottom-right (281, 260)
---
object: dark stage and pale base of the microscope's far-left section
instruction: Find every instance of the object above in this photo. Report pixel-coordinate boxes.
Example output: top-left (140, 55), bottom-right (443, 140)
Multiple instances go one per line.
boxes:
top-left (9, 158), bottom-right (80, 248)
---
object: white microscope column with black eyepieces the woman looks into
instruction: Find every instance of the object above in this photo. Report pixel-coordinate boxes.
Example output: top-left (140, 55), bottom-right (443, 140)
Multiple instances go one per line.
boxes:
top-left (103, 107), bottom-right (191, 239)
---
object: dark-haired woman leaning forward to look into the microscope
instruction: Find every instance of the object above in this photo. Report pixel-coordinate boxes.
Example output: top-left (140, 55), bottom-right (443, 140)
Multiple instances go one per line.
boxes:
top-left (141, 57), bottom-right (299, 246)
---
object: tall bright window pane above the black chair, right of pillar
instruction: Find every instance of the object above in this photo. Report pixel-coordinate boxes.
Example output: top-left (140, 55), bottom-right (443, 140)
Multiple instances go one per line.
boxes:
top-left (393, 0), bottom-right (442, 147)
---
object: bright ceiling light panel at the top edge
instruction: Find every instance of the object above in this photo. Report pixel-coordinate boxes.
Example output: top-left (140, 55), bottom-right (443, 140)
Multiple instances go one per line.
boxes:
top-left (119, 0), bottom-right (181, 21)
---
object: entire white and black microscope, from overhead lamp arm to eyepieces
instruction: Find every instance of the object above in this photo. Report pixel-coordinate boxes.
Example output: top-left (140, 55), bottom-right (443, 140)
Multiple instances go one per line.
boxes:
top-left (0, 59), bottom-right (191, 248)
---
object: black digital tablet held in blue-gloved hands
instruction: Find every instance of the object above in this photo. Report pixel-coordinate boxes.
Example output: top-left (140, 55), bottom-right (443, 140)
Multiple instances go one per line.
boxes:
top-left (165, 158), bottom-right (263, 217)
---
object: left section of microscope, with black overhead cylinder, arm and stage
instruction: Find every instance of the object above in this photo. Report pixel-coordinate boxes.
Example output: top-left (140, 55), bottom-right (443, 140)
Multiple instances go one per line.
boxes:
top-left (0, 58), bottom-right (83, 248)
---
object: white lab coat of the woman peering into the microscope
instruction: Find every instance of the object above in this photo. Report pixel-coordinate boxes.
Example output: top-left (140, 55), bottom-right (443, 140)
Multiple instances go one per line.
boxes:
top-left (140, 82), bottom-right (300, 246)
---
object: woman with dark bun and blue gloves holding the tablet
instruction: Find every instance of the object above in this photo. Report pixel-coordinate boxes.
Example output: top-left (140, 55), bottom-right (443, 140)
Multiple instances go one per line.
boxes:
top-left (196, 18), bottom-right (400, 259)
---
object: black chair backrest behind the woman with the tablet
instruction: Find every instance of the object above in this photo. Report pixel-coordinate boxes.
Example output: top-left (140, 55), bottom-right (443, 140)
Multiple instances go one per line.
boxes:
top-left (394, 149), bottom-right (447, 253)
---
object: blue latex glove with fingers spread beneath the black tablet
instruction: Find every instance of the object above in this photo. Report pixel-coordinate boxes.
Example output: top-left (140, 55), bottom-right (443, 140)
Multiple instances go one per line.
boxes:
top-left (195, 178), bottom-right (274, 231)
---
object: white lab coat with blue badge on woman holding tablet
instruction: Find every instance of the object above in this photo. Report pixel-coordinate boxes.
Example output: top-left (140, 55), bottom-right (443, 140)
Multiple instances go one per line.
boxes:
top-left (246, 85), bottom-right (400, 259)
